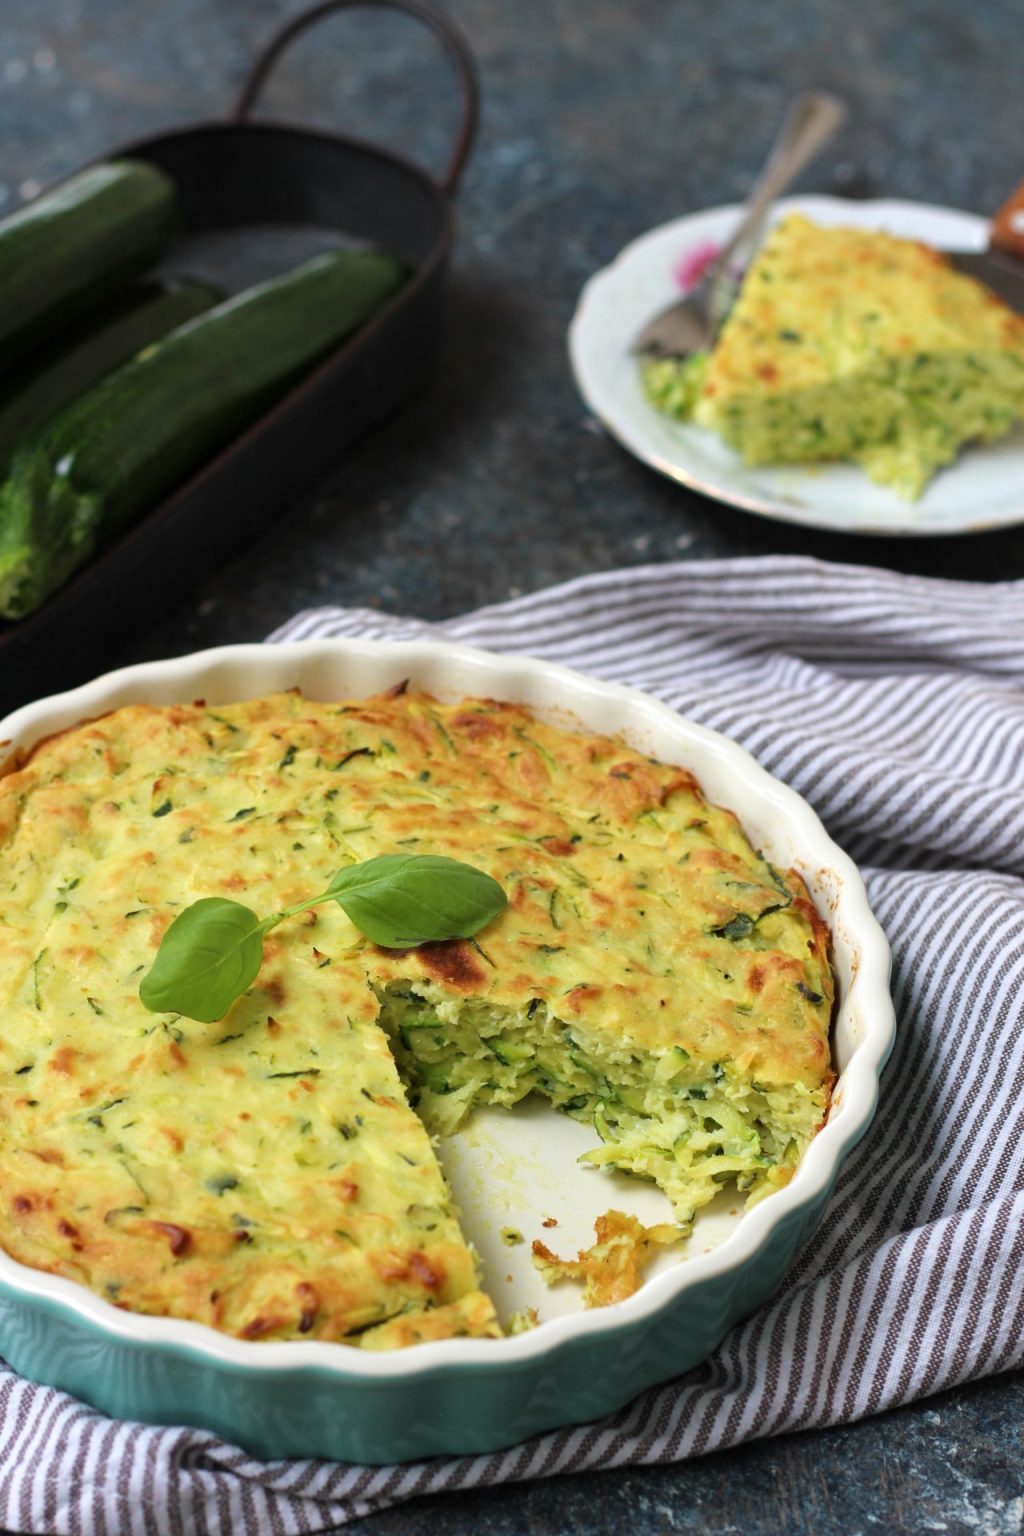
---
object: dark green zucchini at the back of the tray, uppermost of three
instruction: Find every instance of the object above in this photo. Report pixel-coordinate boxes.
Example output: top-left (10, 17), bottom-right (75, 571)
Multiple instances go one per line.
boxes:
top-left (0, 160), bottom-right (175, 372)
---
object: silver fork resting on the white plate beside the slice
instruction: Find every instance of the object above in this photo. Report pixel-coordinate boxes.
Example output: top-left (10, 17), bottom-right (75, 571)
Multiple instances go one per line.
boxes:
top-left (629, 91), bottom-right (846, 358)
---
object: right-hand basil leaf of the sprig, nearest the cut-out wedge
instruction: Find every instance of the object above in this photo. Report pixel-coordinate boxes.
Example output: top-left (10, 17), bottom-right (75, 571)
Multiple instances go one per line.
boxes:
top-left (329, 854), bottom-right (508, 949)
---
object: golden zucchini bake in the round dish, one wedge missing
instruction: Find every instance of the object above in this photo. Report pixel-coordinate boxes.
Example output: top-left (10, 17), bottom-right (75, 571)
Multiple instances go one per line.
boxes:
top-left (0, 691), bottom-right (832, 1349)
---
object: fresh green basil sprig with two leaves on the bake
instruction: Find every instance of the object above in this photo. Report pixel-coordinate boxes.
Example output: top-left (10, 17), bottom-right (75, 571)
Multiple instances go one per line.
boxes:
top-left (138, 854), bottom-right (508, 1025)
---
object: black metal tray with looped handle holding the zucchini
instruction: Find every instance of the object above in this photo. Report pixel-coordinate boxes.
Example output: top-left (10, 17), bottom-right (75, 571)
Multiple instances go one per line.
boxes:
top-left (0, 0), bottom-right (477, 713)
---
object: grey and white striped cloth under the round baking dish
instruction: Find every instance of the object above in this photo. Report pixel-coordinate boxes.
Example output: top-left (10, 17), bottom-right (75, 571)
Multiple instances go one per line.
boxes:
top-left (0, 559), bottom-right (1024, 1536)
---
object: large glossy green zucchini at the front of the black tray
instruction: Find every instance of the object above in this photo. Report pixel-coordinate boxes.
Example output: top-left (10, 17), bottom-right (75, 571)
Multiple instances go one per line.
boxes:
top-left (0, 250), bottom-right (405, 619)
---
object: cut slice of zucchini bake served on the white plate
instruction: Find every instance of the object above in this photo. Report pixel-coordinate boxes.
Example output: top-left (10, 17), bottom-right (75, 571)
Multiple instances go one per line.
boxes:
top-left (643, 214), bottom-right (1024, 501)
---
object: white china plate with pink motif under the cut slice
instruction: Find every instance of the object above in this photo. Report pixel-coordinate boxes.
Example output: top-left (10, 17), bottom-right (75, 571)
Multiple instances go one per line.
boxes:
top-left (570, 197), bottom-right (1024, 536)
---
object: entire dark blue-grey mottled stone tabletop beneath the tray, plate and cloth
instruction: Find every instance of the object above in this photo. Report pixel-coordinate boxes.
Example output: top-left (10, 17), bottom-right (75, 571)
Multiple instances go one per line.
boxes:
top-left (0, 0), bottom-right (1024, 1536)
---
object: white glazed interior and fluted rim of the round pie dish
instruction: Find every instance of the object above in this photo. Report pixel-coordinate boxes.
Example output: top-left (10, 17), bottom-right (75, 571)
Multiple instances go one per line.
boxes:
top-left (0, 641), bottom-right (895, 1378)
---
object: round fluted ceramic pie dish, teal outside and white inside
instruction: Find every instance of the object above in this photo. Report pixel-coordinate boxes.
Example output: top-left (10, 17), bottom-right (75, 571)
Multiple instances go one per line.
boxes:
top-left (0, 641), bottom-right (895, 1462)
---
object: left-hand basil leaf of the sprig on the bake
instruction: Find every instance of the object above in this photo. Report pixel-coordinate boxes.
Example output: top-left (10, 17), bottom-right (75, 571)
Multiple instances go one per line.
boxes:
top-left (138, 895), bottom-right (264, 1025)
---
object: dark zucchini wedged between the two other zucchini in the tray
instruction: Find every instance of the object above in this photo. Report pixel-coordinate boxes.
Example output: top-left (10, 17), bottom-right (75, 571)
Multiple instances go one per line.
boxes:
top-left (0, 283), bottom-right (224, 473)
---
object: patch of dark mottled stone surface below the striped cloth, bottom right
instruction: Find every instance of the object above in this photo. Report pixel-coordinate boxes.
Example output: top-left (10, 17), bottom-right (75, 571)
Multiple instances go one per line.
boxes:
top-left (355, 1376), bottom-right (1024, 1536)
